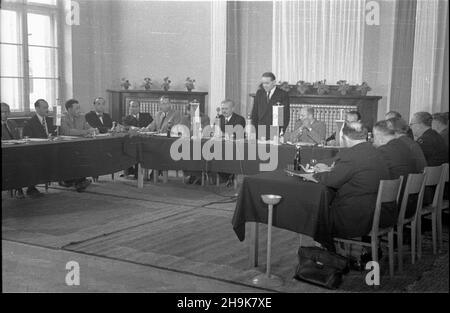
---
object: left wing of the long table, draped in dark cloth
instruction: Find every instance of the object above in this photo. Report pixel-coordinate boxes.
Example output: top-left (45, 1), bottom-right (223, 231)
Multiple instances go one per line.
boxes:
top-left (2, 136), bottom-right (140, 190)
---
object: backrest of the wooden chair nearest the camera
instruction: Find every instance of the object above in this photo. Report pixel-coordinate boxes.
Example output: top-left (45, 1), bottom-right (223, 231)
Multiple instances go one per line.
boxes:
top-left (372, 176), bottom-right (403, 234)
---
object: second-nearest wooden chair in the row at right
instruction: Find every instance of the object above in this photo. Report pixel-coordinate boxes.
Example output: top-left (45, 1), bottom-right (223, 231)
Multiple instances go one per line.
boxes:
top-left (397, 173), bottom-right (426, 272)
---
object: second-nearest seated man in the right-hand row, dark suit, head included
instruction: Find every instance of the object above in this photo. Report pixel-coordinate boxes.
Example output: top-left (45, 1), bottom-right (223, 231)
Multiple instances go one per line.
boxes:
top-left (373, 121), bottom-right (420, 181)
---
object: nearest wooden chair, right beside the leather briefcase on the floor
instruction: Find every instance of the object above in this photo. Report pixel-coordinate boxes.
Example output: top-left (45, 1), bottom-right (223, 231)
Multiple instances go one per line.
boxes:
top-left (334, 176), bottom-right (403, 277)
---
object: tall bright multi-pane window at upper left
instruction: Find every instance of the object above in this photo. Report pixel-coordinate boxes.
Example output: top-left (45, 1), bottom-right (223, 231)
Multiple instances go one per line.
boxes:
top-left (0, 0), bottom-right (61, 112)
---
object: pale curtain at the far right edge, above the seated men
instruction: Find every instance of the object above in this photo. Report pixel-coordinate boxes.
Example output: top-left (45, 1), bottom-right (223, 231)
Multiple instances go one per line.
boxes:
top-left (410, 0), bottom-right (448, 116)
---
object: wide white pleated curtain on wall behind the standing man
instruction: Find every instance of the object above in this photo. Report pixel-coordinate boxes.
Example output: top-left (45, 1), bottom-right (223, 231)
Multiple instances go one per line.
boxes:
top-left (272, 0), bottom-right (365, 84)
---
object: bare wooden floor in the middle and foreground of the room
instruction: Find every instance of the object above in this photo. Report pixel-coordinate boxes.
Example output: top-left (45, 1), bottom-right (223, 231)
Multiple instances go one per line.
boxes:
top-left (2, 176), bottom-right (448, 292)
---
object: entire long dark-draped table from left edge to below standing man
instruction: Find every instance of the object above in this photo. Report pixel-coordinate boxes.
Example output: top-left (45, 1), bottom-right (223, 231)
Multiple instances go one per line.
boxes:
top-left (2, 134), bottom-right (338, 190)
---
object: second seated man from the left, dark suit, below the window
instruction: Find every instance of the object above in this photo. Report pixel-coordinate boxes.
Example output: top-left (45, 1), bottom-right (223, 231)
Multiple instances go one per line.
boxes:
top-left (23, 99), bottom-right (56, 197)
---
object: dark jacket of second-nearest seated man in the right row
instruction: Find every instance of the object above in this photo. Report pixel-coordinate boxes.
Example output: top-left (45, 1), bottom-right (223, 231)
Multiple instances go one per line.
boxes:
top-left (377, 139), bottom-right (421, 181)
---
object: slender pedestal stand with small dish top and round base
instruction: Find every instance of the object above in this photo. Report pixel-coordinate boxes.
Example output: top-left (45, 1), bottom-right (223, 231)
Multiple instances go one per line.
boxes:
top-left (252, 195), bottom-right (283, 287)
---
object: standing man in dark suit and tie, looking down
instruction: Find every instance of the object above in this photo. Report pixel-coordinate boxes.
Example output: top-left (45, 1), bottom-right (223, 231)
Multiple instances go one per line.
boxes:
top-left (251, 72), bottom-right (290, 139)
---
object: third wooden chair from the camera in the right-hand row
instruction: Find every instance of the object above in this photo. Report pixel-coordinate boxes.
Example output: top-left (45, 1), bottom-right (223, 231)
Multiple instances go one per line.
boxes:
top-left (417, 165), bottom-right (446, 259)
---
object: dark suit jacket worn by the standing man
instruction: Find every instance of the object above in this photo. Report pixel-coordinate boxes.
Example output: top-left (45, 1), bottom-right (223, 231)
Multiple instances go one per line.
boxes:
top-left (251, 87), bottom-right (290, 138)
